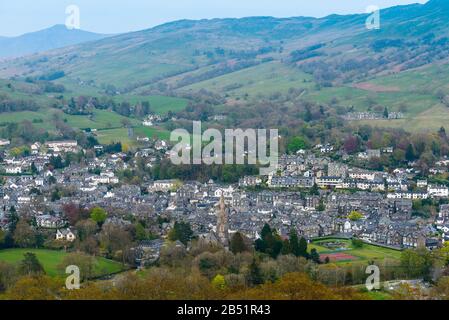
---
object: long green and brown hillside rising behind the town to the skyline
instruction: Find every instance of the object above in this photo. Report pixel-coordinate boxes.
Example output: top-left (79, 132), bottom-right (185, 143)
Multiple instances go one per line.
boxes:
top-left (0, 0), bottom-right (449, 130)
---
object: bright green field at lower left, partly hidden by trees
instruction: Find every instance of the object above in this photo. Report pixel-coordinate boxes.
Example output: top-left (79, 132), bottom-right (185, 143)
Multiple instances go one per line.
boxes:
top-left (0, 249), bottom-right (123, 276)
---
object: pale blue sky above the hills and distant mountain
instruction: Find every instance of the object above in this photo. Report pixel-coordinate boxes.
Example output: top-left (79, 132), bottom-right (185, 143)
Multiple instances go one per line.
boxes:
top-left (0, 0), bottom-right (427, 36)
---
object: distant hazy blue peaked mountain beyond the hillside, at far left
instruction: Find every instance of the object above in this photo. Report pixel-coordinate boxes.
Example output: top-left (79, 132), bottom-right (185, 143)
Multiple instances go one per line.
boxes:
top-left (0, 25), bottom-right (106, 58)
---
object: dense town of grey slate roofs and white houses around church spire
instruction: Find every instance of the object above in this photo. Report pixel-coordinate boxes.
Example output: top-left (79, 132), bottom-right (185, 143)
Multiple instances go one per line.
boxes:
top-left (0, 135), bottom-right (449, 264)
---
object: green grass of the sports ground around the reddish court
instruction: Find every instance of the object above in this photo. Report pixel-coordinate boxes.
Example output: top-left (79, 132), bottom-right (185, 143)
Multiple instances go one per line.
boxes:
top-left (309, 239), bottom-right (401, 264)
